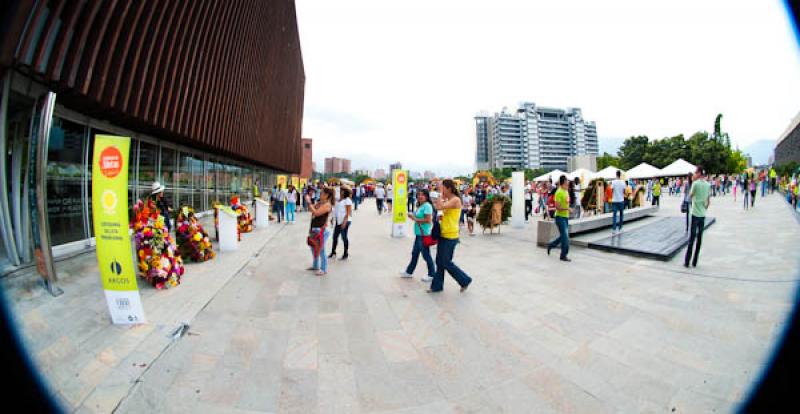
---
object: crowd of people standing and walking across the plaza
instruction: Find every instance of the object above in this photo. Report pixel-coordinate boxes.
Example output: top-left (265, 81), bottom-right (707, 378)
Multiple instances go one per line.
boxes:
top-left (250, 162), bottom-right (800, 292)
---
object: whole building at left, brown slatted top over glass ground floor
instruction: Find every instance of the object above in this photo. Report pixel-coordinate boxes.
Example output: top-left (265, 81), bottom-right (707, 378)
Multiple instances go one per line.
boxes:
top-left (0, 0), bottom-right (305, 274)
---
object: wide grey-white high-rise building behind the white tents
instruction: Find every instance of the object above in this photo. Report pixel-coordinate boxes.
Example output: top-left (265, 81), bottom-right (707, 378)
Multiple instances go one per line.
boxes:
top-left (474, 102), bottom-right (599, 170)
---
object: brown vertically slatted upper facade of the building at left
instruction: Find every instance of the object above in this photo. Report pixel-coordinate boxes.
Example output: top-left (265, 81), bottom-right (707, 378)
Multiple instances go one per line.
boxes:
top-left (0, 0), bottom-right (305, 173)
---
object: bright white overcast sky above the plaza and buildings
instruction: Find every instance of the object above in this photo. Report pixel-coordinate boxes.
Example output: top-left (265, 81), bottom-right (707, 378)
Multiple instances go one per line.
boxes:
top-left (296, 0), bottom-right (800, 175)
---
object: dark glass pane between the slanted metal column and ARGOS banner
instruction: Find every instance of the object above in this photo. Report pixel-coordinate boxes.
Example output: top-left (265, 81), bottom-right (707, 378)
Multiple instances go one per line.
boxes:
top-left (47, 117), bottom-right (86, 246)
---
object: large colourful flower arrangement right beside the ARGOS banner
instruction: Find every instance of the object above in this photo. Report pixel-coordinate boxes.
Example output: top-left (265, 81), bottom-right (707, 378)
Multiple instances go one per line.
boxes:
top-left (131, 200), bottom-right (184, 289)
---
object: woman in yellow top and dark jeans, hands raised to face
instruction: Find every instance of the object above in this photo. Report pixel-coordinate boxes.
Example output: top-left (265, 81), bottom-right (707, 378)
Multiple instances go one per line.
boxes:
top-left (428, 179), bottom-right (472, 292)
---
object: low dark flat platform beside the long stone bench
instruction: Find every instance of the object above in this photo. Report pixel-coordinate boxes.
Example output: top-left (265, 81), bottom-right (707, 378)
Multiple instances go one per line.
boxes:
top-left (588, 217), bottom-right (716, 260)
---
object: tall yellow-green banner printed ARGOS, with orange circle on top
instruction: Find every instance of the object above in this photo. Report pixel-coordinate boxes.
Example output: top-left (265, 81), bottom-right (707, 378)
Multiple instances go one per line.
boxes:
top-left (92, 135), bottom-right (146, 324)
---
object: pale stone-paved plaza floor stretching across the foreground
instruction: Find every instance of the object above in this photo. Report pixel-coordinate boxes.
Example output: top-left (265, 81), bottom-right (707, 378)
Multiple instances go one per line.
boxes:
top-left (1, 195), bottom-right (800, 413)
